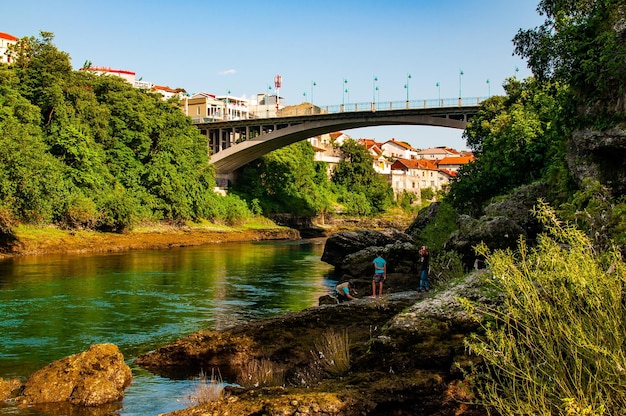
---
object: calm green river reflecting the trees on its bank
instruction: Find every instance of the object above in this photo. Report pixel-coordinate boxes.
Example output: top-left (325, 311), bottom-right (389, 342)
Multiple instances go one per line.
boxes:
top-left (0, 240), bottom-right (334, 416)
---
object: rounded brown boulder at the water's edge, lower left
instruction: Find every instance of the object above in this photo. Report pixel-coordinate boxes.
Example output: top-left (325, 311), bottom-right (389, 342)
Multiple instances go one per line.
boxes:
top-left (19, 344), bottom-right (132, 406)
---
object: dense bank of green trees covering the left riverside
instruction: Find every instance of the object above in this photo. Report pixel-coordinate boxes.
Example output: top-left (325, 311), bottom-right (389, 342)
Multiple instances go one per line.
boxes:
top-left (0, 32), bottom-right (250, 231)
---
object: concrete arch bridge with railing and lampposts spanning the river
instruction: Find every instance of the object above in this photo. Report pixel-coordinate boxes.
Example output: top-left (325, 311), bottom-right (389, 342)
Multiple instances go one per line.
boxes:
top-left (195, 98), bottom-right (483, 177)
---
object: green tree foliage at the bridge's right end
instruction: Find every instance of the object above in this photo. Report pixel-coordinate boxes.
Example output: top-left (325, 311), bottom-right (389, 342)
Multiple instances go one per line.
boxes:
top-left (448, 78), bottom-right (569, 215)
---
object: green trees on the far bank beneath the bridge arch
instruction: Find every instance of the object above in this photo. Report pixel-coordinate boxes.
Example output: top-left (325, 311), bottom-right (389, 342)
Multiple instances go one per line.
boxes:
top-left (232, 140), bottom-right (393, 217)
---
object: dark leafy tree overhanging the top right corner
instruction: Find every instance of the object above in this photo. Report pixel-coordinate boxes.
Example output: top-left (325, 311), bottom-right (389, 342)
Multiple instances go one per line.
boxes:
top-left (513, 0), bottom-right (626, 125)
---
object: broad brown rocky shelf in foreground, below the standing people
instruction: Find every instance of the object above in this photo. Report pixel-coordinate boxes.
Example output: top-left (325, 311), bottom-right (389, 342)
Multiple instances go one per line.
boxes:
top-left (136, 275), bottom-right (486, 416)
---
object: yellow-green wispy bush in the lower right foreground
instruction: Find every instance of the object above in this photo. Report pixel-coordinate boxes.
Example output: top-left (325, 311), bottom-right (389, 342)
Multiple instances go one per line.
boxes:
top-left (465, 204), bottom-right (626, 416)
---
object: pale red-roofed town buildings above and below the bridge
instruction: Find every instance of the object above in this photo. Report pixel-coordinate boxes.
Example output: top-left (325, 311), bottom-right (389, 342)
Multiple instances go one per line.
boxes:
top-left (0, 32), bottom-right (474, 201)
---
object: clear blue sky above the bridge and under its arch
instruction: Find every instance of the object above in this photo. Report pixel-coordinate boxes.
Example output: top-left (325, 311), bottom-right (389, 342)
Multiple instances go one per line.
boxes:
top-left (0, 0), bottom-right (543, 150)
